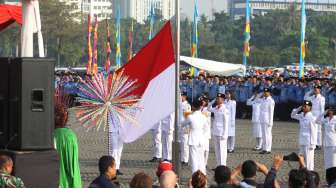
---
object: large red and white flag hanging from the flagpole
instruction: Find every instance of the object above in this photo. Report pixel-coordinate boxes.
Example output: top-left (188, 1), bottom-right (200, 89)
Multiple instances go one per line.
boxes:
top-left (120, 22), bottom-right (175, 143)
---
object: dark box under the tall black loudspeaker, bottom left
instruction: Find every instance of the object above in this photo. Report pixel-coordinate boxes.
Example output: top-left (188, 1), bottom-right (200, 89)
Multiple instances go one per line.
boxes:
top-left (0, 150), bottom-right (59, 188)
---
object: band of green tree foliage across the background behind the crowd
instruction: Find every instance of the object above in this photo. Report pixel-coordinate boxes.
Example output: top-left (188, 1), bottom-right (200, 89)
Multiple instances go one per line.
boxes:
top-left (0, 0), bottom-right (336, 66)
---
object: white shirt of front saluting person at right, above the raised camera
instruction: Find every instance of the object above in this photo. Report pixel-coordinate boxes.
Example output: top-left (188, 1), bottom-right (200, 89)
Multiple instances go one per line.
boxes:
top-left (291, 108), bottom-right (317, 146)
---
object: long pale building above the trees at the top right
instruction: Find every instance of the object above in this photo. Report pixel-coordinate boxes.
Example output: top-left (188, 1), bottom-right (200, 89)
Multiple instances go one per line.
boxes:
top-left (229, 0), bottom-right (336, 19)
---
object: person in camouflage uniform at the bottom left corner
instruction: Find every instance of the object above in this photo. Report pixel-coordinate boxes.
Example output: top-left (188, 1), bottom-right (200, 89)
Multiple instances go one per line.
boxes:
top-left (0, 155), bottom-right (25, 188)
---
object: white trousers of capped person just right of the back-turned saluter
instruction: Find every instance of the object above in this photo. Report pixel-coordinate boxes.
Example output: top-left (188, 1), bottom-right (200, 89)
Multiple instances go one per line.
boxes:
top-left (213, 136), bottom-right (227, 166)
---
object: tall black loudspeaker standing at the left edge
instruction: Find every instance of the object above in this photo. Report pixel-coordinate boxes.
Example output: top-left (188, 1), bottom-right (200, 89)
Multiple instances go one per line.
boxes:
top-left (0, 58), bottom-right (54, 150)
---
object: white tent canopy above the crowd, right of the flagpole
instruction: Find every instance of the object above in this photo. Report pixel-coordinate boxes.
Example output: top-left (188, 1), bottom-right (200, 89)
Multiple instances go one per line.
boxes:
top-left (180, 56), bottom-right (245, 76)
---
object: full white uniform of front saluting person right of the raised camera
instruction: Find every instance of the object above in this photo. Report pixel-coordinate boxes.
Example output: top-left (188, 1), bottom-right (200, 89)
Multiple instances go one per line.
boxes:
top-left (291, 109), bottom-right (317, 170)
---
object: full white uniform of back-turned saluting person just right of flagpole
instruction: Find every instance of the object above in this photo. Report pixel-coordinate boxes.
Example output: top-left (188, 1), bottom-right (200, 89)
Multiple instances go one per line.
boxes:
top-left (183, 110), bottom-right (208, 174)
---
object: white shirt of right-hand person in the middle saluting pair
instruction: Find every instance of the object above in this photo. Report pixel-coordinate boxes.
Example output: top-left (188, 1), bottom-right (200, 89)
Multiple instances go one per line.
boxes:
top-left (259, 96), bottom-right (275, 126)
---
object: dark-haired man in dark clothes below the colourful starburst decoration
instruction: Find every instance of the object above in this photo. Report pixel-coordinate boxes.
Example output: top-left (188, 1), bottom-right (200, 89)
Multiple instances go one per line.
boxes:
top-left (89, 156), bottom-right (117, 188)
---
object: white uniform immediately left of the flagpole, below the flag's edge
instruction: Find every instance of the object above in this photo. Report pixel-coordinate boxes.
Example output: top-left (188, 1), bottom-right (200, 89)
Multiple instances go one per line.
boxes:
top-left (161, 113), bottom-right (175, 161)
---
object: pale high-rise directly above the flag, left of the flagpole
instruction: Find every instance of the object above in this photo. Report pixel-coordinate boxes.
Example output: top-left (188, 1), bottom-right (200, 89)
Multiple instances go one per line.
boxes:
top-left (112, 0), bottom-right (175, 23)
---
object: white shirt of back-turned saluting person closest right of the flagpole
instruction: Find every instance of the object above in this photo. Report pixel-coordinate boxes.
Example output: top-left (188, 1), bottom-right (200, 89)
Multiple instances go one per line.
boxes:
top-left (182, 110), bottom-right (208, 146)
